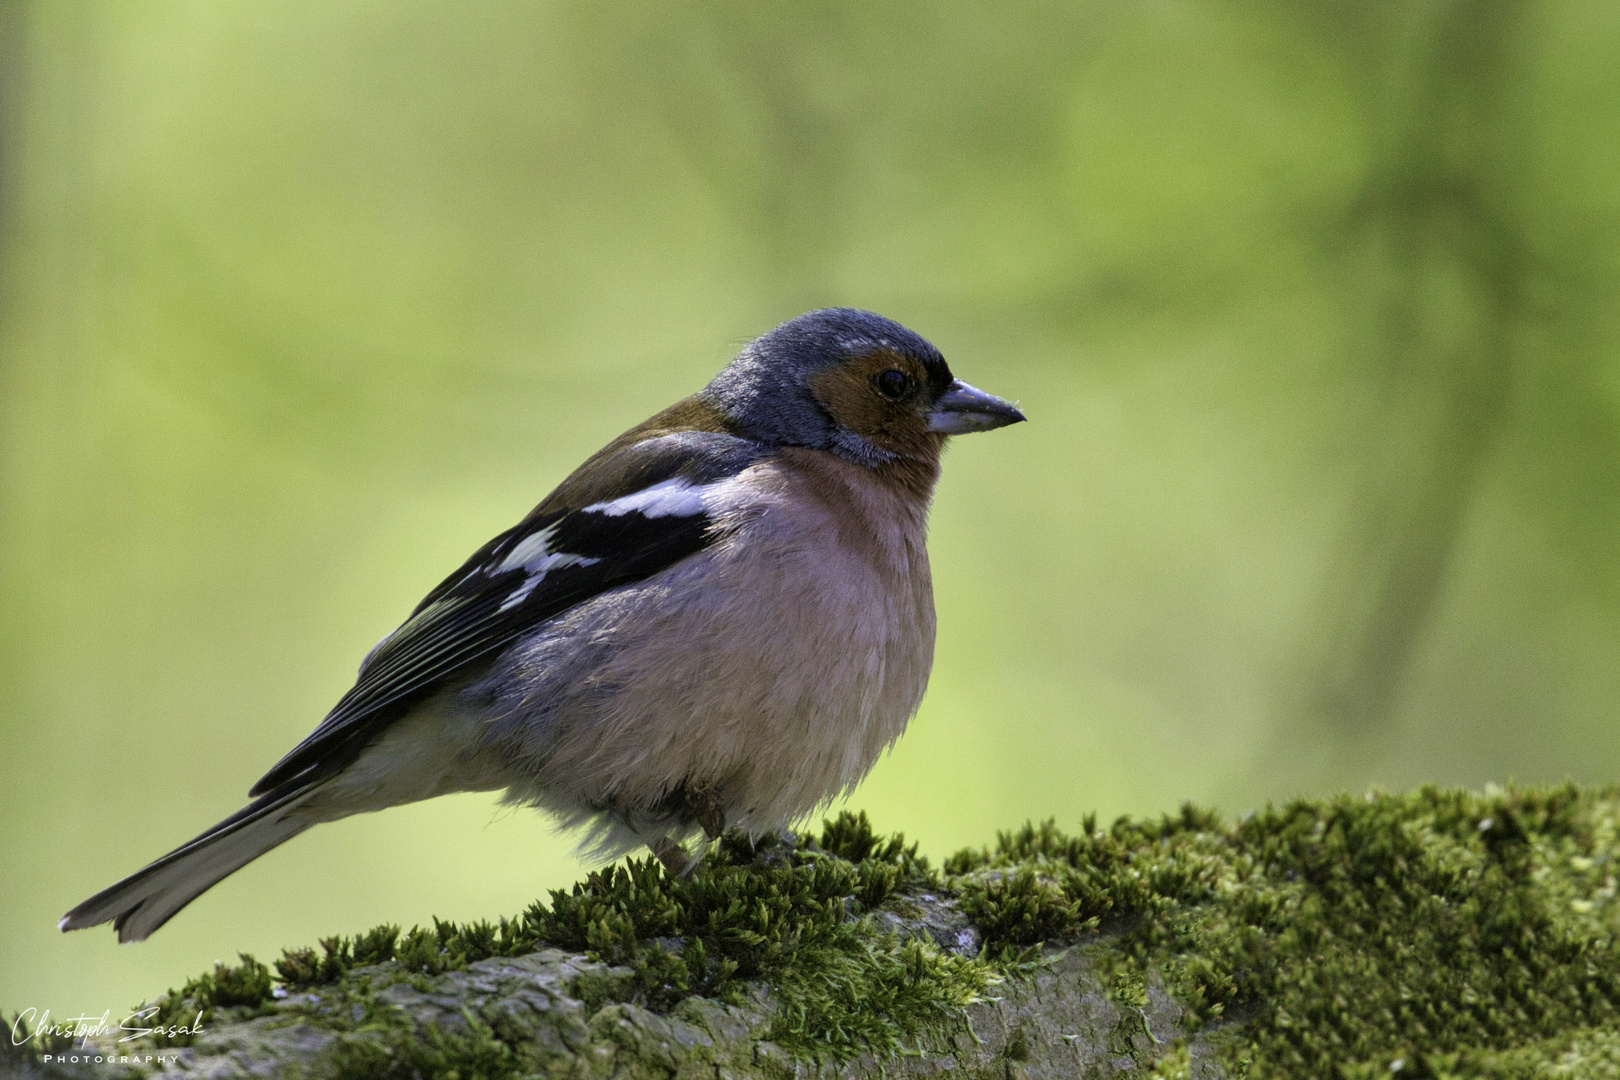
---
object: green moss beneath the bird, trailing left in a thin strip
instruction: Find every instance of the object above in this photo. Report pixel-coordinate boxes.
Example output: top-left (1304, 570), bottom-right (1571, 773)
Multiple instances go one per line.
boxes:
top-left (264, 813), bottom-right (995, 1061)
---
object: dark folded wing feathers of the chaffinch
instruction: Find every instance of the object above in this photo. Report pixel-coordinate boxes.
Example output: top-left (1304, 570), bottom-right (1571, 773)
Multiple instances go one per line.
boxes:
top-left (251, 432), bottom-right (770, 795)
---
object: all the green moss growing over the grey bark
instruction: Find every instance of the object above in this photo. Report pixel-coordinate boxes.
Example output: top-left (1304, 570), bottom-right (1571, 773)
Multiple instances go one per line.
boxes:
top-left (110, 785), bottom-right (1620, 1078)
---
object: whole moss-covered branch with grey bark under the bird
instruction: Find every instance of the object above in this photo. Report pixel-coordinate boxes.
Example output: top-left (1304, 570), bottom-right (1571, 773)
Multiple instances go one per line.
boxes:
top-left (3, 785), bottom-right (1620, 1080)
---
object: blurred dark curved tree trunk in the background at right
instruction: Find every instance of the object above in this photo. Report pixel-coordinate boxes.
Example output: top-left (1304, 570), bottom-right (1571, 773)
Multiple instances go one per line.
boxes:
top-left (1307, 0), bottom-right (1531, 733)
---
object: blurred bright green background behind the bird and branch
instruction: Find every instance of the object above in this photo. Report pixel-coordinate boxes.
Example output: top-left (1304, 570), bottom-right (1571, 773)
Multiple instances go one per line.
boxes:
top-left (0, 0), bottom-right (1620, 1018)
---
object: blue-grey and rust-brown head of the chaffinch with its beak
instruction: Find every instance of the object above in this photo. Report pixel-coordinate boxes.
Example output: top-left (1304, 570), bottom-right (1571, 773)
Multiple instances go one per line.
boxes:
top-left (700, 308), bottom-right (1024, 466)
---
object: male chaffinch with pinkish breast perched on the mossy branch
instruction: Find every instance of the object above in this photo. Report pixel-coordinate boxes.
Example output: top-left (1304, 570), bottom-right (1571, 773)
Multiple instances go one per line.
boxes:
top-left (58, 308), bottom-right (1024, 941)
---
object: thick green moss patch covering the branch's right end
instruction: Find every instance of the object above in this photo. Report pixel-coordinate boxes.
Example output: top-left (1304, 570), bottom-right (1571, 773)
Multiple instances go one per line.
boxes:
top-left (948, 785), bottom-right (1620, 1077)
